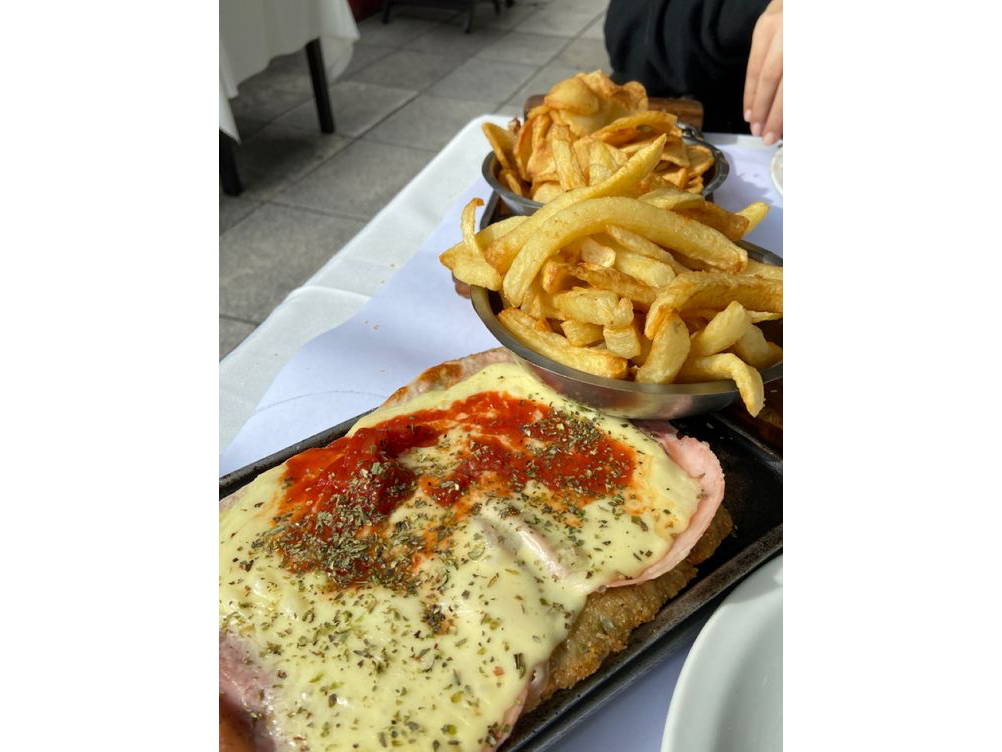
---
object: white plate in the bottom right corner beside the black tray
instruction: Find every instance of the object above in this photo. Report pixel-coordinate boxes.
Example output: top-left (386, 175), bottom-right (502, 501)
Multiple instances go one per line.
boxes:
top-left (661, 554), bottom-right (783, 752)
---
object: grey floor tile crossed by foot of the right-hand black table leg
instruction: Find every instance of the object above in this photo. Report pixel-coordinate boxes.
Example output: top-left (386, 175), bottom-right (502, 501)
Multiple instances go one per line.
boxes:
top-left (276, 81), bottom-right (418, 138)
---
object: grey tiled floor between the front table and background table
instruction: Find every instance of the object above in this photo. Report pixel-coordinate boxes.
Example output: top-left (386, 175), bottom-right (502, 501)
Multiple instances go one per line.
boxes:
top-left (219, 0), bottom-right (609, 360)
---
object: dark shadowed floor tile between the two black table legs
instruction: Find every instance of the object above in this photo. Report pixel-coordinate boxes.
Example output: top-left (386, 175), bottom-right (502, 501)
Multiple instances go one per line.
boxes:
top-left (236, 125), bottom-right (351, 199)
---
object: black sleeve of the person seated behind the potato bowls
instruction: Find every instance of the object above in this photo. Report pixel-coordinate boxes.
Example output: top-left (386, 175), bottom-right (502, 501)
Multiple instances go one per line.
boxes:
top-left (605, 0), bottom-right (769, 131)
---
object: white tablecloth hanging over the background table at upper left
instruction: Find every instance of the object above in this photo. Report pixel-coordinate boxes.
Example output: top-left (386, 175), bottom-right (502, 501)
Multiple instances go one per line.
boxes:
top-left (219, 0), bottom-right (359, 140)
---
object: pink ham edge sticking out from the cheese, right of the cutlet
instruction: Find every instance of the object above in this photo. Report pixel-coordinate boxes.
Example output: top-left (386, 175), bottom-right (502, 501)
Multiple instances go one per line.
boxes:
top-left (607, 420), bottom-right (723, 588)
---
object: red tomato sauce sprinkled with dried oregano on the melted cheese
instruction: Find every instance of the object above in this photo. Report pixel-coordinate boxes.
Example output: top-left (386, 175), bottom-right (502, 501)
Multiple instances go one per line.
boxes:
top-left (275, 391), bottom-right (634, 585)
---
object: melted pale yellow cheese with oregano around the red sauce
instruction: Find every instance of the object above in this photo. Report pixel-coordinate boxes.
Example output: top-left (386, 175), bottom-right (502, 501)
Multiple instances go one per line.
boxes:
top-left (219, 363), bottom-right (699, 752)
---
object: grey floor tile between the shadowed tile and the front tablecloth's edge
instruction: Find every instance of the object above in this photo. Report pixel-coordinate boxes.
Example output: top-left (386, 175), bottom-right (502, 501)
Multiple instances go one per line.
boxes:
top-left (275, 140), bottom-right (435, 218)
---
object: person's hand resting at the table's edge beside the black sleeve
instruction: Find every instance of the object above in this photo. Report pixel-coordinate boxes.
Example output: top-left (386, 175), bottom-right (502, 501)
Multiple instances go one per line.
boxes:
top-left (744, 0), bottom-right (783, 145)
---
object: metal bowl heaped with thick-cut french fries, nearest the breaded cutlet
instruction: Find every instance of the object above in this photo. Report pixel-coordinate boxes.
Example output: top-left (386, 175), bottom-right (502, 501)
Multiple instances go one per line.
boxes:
top-left (440, 134), bottom-right (783, 425)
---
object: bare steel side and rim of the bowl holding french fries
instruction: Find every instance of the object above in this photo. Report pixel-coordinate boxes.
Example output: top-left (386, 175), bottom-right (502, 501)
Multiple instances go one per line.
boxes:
top-left (470, 241), bottom-right (783, 419)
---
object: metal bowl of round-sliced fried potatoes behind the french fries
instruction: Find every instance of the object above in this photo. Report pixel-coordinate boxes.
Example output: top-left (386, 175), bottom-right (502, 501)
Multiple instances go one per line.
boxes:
top-left (482, 70), bottom-right (729, 215)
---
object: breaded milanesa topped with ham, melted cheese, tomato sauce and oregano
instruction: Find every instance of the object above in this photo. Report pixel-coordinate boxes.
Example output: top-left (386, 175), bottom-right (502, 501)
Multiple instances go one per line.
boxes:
top-left (219, 350), bottom-right (731, 752)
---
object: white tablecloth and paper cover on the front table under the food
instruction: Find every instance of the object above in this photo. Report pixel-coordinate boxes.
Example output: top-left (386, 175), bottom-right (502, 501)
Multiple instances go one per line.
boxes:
top-left (219, 115), bottom-right (783, 752)
